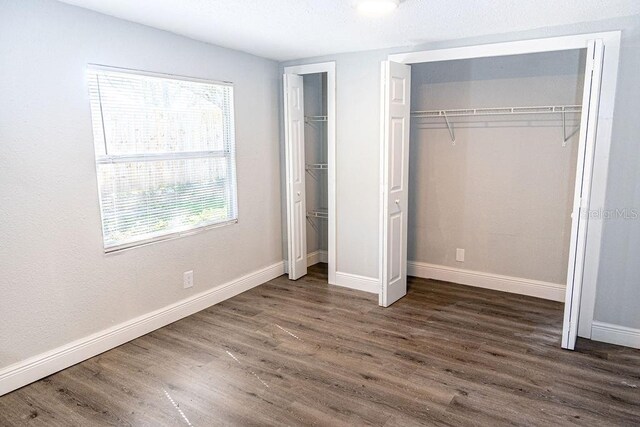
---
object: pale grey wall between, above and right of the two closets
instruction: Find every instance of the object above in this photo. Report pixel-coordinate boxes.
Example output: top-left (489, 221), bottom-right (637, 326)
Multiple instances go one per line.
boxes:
top-left (281, 16), bottom-right (640, 328)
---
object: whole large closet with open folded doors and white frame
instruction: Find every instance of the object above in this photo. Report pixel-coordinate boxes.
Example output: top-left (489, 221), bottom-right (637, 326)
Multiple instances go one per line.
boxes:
top-left (380, 33), bottom-right (619, 349)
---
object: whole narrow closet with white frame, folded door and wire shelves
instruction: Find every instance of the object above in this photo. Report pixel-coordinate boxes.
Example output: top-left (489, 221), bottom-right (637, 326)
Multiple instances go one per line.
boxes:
top-left (284, 63), bottom-right (335, 284)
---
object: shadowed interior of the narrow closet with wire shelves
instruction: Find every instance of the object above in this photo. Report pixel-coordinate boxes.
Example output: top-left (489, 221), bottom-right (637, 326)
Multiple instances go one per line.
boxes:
top-left (303, 73), bottom-right (328, 263)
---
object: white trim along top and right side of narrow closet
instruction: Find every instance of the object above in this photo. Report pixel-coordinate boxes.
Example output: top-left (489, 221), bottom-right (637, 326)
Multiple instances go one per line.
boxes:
top-left (284, 62), bottom-right (337, 285)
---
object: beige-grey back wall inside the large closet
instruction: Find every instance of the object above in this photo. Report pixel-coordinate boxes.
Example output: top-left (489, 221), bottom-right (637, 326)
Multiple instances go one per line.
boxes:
top-left (408, 50), bottom-right (586, 286)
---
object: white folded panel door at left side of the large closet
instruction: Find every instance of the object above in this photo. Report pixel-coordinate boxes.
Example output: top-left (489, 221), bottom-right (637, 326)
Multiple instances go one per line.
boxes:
top-left (379, 61), bottom-right (411, 307)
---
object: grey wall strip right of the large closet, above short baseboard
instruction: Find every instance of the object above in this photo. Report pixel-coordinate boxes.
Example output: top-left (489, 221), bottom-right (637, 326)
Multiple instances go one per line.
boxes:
top-left (594, 16), bottom-right (640, 330)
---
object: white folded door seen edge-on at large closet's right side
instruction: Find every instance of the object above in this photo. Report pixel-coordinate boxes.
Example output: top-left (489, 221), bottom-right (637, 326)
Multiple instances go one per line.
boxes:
top-left (562, 40), bottom-right (604, 350)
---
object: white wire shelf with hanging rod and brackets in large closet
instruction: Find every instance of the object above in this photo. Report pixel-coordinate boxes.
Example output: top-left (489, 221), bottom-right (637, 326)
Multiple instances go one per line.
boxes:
top-left (411, 105), bottom-right (582, 147)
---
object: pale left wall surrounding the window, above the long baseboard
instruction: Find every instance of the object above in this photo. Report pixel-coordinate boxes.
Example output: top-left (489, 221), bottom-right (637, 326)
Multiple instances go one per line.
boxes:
top-left (0, 0), bottom-right (282, 368)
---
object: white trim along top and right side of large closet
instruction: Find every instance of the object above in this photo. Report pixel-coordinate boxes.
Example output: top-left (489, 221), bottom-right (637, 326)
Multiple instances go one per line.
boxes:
top-left (388, 31), bottom-right (621, 346)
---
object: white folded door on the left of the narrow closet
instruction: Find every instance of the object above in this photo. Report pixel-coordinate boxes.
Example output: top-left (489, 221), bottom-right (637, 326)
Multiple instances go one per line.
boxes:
top-left (284, 74), bottom-right (307, 280)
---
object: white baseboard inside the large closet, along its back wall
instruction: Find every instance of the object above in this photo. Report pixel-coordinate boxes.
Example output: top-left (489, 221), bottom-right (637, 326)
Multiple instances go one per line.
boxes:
top-left (407, 261), bottom-right (565, 302)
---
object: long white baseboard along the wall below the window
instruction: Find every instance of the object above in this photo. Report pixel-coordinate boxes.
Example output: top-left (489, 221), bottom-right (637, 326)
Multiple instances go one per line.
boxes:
top-left (0, 261), bottom-right (284, 396)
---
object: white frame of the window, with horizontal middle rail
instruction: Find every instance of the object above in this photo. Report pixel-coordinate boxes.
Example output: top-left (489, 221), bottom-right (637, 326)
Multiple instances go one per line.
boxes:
top-left (85, 63), bottom-right (239, 254)
